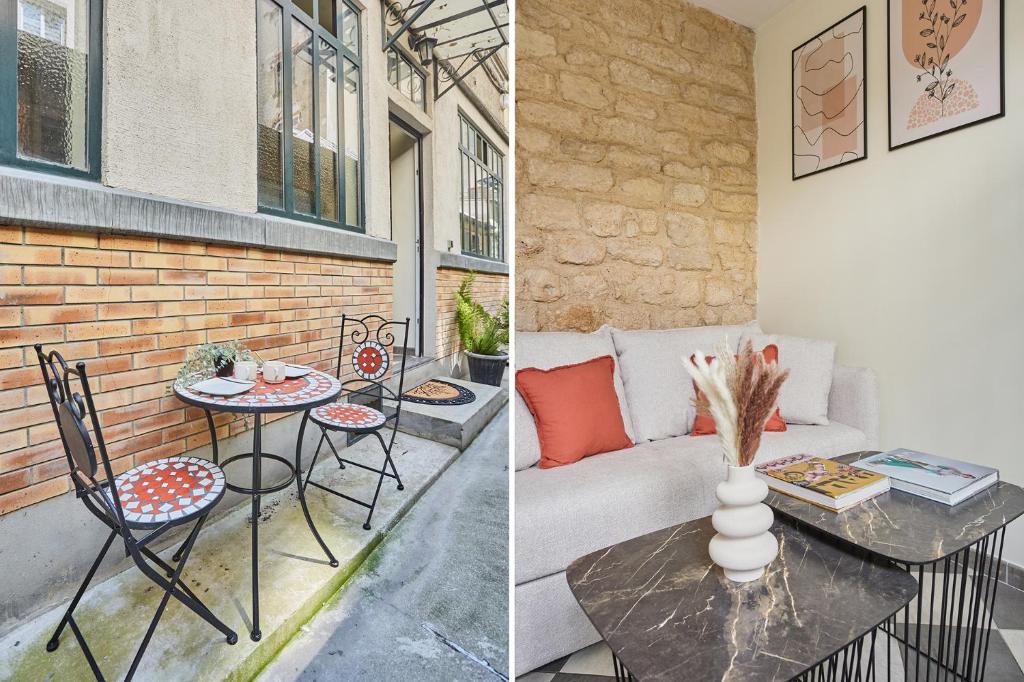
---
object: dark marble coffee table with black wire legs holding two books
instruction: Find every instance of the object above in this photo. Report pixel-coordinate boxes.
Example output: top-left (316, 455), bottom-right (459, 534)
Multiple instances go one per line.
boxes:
top-left (765, 452), bottom-right (1024, 681)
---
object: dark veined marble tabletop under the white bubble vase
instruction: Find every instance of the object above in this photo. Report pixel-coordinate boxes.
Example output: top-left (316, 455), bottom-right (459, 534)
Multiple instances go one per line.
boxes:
top-left (566, 517), bottom-right (918, 682)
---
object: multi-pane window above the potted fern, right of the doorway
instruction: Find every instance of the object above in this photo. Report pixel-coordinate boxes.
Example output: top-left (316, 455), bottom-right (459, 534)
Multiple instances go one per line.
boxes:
top-left (459, 114), bottom-right (505, 260)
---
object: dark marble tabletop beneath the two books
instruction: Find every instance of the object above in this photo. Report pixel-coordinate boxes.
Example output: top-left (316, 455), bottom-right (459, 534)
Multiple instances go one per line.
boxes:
top-left (765, 451), bottom-right (1024, 564)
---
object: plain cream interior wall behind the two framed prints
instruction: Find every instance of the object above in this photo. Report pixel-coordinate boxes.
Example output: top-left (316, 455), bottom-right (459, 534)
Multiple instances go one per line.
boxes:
top-left (755, 0), bottom-right (1024, 564)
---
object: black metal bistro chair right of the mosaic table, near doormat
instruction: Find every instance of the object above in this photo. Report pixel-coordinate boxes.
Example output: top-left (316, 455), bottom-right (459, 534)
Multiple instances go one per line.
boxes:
top-left (299, 314), bottom-right (409, 530)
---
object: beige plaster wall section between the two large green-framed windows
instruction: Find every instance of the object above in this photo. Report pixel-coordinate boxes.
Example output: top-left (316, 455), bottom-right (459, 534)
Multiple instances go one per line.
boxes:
top-left (102, 0), bottom-right (256, 212)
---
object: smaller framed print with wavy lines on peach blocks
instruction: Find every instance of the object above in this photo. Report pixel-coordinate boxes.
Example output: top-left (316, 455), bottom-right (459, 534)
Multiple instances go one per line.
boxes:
top-left (793, 7), bottom-right (867, 179)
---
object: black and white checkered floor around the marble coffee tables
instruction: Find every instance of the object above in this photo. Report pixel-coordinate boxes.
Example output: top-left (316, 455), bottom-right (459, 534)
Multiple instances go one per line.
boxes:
top-left (516, 583), bottom-right (1024, 682)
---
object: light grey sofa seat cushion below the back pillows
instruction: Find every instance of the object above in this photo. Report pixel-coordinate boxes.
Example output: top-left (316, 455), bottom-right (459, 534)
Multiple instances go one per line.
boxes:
top-left (515, 422), bottom-right (865, 584)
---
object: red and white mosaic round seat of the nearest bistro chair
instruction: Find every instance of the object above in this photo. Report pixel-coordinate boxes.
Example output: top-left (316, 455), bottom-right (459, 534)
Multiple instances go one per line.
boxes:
top-left (108, 457), bottom-right (224, 523)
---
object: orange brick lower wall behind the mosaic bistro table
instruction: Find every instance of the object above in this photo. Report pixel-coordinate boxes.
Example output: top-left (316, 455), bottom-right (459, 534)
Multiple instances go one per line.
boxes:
top-left (0, 226), bottom-right (392, 514)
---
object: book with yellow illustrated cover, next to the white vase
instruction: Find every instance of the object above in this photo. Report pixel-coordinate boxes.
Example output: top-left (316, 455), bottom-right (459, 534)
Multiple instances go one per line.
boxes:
top-left (756, 455), bottom-right (889, 512)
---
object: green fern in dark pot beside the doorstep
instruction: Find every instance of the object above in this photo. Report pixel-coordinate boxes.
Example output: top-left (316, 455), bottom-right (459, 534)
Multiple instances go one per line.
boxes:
top-left (455, 272), bottom-right (509, 386)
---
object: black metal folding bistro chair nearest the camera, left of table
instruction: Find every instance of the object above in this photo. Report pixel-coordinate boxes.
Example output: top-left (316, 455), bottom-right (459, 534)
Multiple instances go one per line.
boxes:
top-left (36, 344), bottom-right (239, 680)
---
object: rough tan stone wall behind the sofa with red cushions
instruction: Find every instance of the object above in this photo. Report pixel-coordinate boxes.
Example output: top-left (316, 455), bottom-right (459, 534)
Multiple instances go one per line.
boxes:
top-left (516, 0), bottom-right (757, 331)
